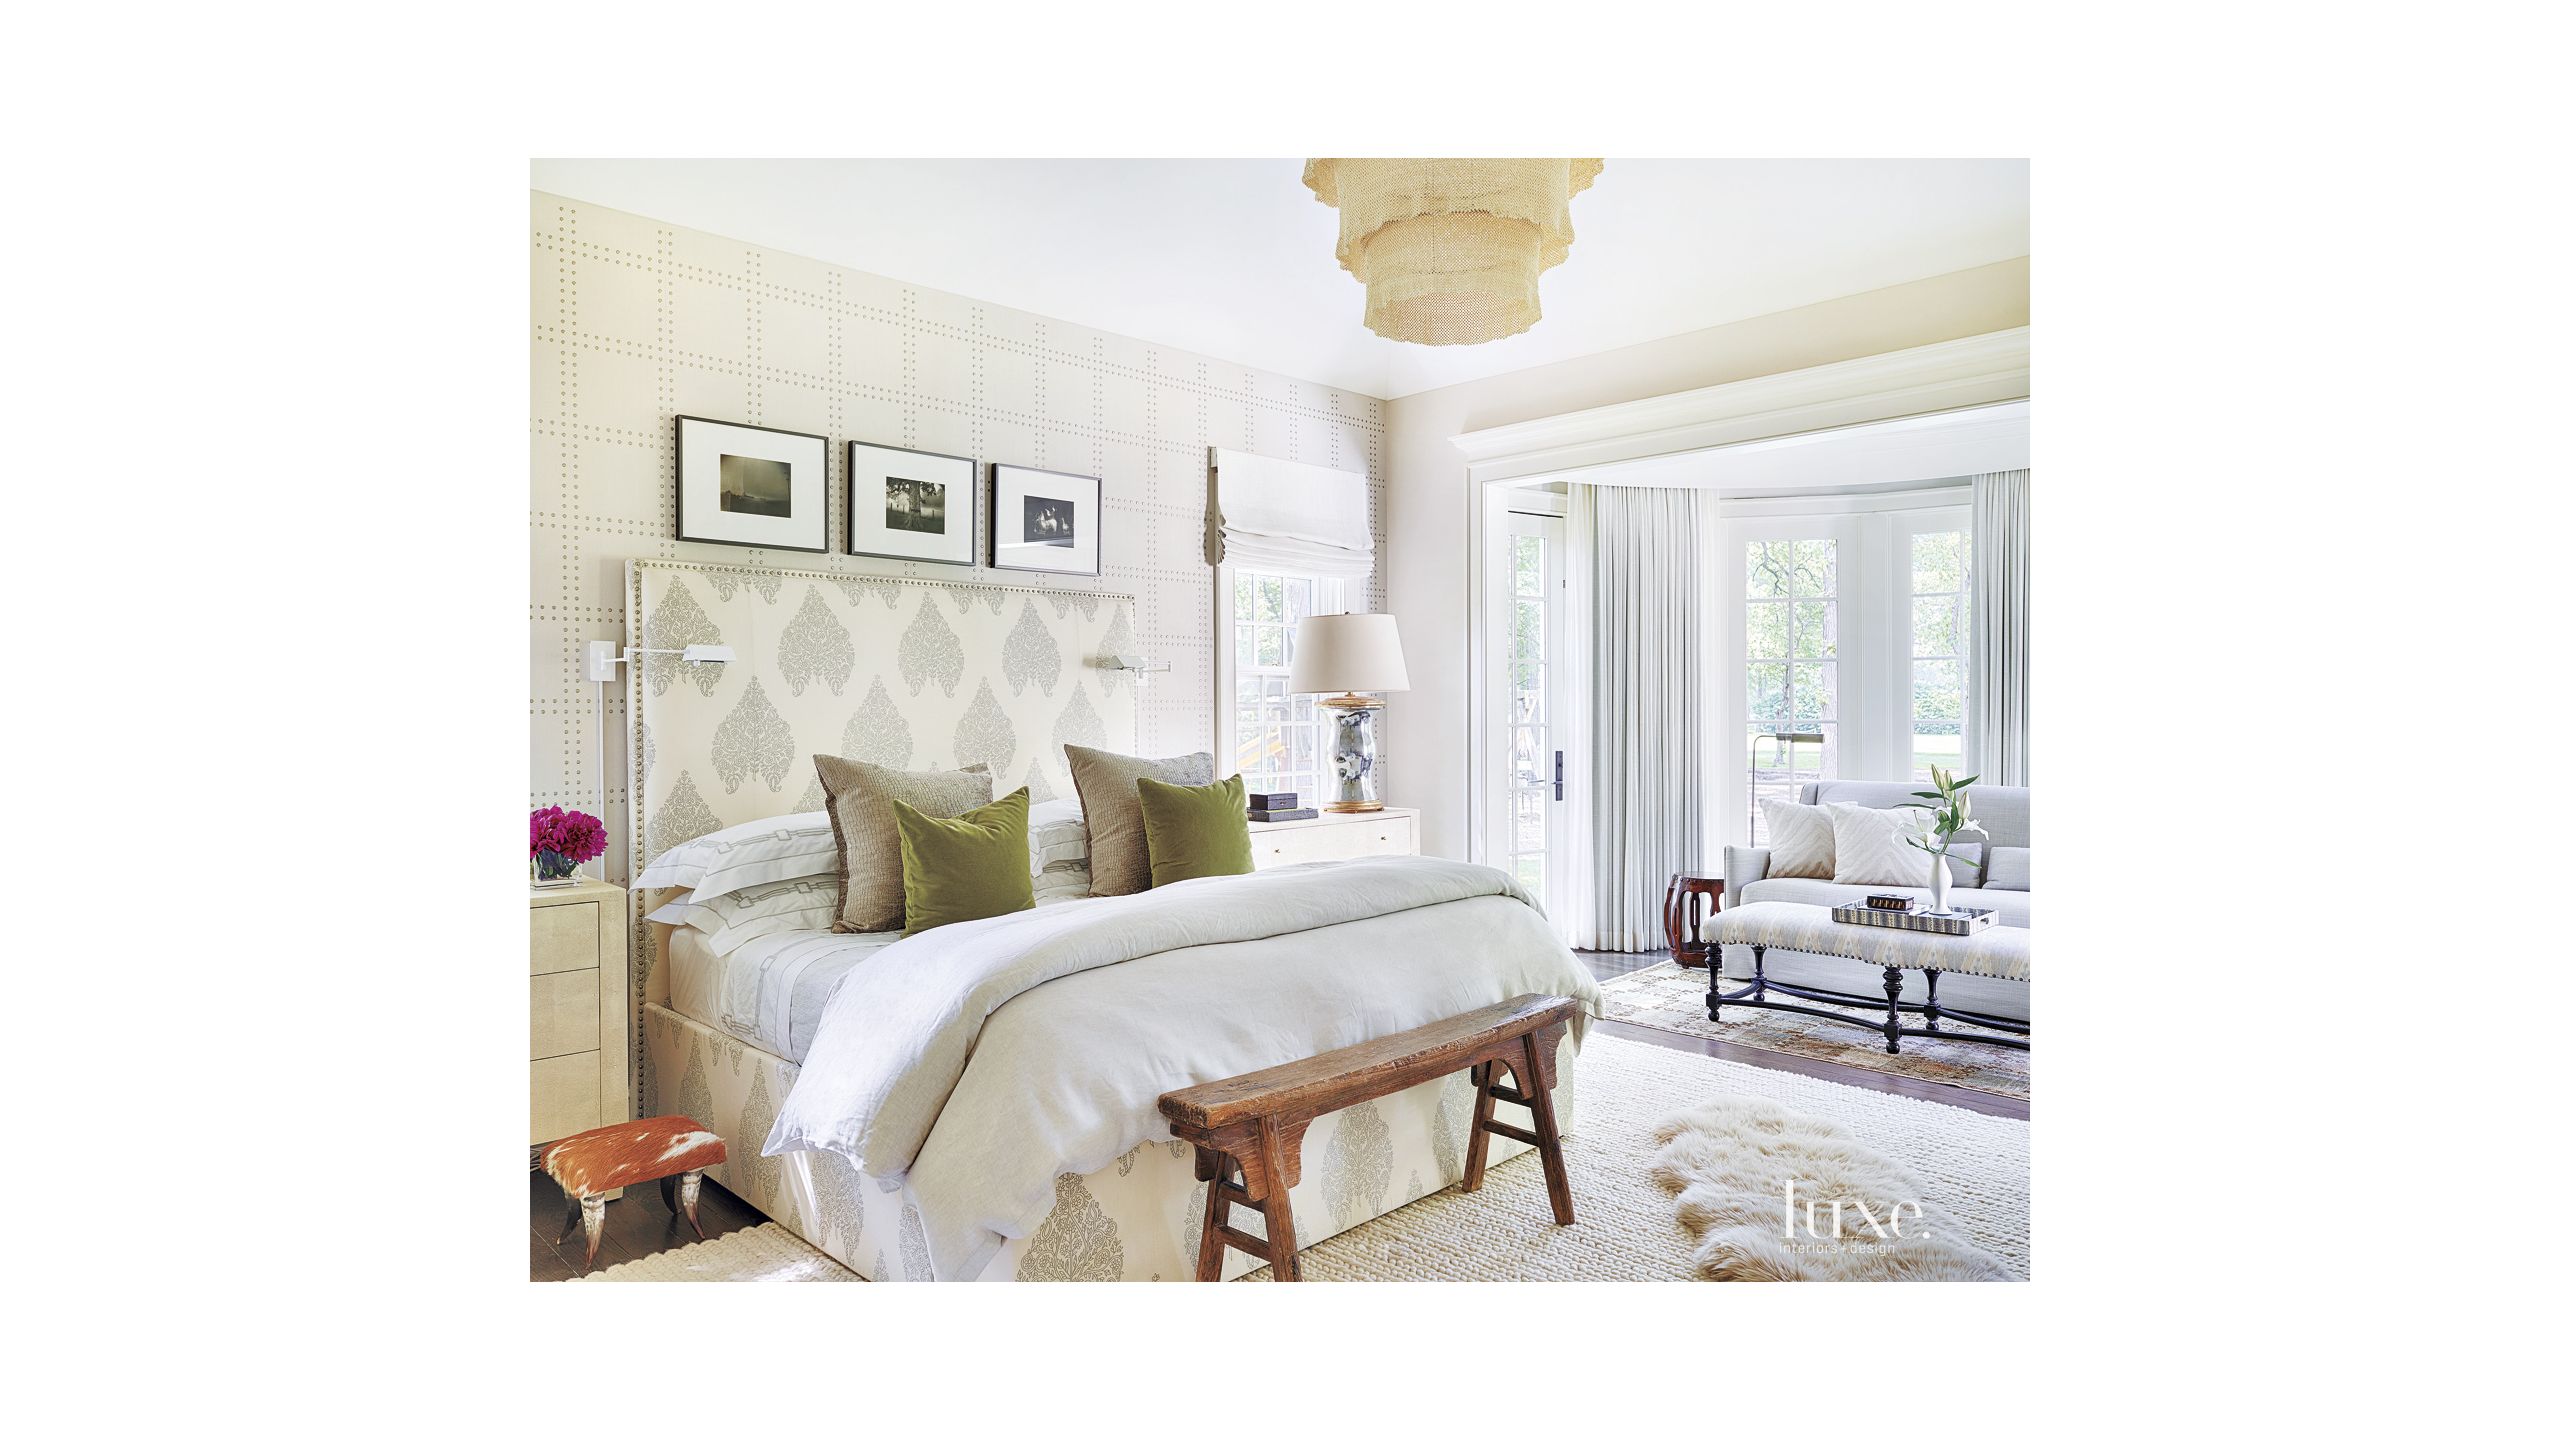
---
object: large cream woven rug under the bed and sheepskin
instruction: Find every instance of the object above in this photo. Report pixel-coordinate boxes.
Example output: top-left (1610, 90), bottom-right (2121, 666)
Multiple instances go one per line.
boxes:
top-left (589, 1035), bottom-right (2028, 1281)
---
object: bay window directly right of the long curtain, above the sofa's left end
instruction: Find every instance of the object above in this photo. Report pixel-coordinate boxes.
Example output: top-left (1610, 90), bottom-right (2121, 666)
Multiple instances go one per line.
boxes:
top-left (1743, 536), bottom-right (1841, 825)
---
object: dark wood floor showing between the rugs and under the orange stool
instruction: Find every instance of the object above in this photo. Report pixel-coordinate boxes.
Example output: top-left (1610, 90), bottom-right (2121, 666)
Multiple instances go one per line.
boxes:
top-left (530, 951), bottom-right (2028, 1281)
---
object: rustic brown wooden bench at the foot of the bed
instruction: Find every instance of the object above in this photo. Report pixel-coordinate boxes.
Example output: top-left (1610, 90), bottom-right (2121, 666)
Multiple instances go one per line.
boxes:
top-left (1157, 994), bottom-right (1574, 1281)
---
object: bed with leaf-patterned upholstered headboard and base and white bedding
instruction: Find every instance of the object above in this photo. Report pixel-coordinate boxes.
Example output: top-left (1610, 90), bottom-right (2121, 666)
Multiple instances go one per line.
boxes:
top-left (627, 561), bottom-right (1597, 1281)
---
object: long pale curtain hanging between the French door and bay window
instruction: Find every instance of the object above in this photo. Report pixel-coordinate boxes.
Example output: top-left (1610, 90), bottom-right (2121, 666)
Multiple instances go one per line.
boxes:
top-left (1556, 484), bottom-right (1713, 951)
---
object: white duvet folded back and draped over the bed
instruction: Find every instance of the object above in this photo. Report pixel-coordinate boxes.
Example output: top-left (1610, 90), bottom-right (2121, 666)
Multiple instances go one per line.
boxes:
top-left (765, 856), bottom-right (1600, 1279)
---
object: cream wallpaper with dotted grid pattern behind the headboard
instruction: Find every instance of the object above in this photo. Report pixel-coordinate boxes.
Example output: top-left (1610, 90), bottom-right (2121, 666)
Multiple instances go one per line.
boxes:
top-left (532, 192), bottom-right (1385, 881)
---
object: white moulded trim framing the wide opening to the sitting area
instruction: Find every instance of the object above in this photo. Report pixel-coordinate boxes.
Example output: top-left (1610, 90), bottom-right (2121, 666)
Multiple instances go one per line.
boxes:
top-left (1449, 325), bottom-right (2028, 863)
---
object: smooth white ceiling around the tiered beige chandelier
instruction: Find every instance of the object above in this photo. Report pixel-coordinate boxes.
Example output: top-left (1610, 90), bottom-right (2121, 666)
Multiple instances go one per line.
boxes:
top-left (532, 159), bottom-right (2028, 400)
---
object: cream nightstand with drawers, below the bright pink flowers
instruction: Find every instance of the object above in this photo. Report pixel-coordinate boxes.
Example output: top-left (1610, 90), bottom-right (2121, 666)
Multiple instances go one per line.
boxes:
top-left (532, 881), bottom-right (632, 1145)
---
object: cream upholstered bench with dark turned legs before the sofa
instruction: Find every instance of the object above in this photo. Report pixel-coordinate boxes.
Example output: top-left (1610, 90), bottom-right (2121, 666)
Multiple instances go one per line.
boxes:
top-left (1682, 892), bottom-right (2028, 1056)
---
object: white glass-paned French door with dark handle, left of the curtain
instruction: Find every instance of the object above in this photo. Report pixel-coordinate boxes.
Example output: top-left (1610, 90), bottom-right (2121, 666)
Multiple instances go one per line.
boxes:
top-left (1485, 512), bottom-right (1567, 912)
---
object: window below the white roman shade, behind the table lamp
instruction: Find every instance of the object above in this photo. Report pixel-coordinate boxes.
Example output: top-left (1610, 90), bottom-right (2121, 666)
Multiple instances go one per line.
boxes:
top-left (1224, 569), bottom-right (1341, 805)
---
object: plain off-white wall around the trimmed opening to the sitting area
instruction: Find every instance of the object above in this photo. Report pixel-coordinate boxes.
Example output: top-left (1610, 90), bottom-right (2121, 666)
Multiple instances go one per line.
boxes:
top-left (1372, 259), bottom-right (2028, 858)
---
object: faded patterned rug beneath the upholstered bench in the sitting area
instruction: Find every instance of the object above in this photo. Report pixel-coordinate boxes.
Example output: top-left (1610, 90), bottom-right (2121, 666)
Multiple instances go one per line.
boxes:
top-left (1600, 961), bottom-right (2028, 1099)
